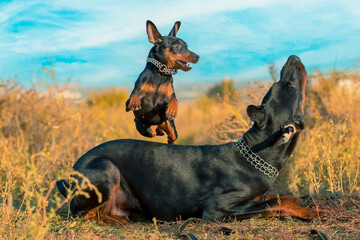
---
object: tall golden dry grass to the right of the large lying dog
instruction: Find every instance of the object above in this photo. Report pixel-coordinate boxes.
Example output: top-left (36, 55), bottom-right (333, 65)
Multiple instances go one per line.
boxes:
top-left (290, 72), bottom-right (360, 196)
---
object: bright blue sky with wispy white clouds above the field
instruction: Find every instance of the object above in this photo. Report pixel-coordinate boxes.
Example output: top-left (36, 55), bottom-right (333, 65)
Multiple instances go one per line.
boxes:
top-left (0, 0), bottom-right (360, 87)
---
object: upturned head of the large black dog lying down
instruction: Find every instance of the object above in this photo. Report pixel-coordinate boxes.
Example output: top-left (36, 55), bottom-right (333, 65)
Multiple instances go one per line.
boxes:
top-left (247, 55), bottom-right (307, 146)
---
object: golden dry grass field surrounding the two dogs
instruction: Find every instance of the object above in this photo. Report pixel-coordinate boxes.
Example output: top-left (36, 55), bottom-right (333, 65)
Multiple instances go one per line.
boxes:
top-left (0, 69), bottom-right (360, 239)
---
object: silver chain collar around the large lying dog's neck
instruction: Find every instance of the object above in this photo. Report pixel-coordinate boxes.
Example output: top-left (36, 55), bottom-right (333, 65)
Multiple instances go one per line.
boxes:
top-left (235, 138), bottom-right (279, 179)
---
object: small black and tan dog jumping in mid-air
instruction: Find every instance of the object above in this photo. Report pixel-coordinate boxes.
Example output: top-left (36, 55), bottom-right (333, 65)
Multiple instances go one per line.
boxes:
top-left (126, 21), bottom-right (200, 144)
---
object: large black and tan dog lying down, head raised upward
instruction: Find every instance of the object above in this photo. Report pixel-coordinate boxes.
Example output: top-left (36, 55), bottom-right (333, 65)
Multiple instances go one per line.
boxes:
top-left (57, 56), bottom-right (324, 224)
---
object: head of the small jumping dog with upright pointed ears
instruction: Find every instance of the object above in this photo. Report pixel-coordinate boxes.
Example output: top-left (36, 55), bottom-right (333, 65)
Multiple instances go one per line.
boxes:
top-left (146, 20), bottom-right (200, 71)
